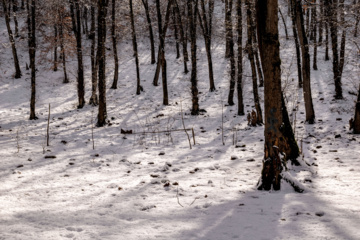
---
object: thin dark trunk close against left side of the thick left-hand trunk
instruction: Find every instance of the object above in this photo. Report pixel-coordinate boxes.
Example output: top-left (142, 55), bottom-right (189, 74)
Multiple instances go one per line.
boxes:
top-left (89, 3), bottom-right (99, 106)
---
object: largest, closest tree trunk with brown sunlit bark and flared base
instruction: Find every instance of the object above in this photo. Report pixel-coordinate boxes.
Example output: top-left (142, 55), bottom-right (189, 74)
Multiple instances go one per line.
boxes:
top-left (256, 0), bottom-right (299, 190)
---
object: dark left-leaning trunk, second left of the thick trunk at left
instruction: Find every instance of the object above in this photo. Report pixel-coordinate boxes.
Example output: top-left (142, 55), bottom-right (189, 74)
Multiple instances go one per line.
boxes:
top-left (70, 0), bottom-right (85, 108)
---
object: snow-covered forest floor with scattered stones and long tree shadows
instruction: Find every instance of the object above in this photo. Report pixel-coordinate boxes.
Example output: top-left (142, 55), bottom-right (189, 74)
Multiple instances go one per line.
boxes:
top-left (0, 7), bottom-right (360, 240)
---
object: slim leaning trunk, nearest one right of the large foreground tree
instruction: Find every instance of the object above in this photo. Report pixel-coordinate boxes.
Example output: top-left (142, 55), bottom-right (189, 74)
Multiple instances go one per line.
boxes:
top-left (292, 0), bottom-right (315, 124)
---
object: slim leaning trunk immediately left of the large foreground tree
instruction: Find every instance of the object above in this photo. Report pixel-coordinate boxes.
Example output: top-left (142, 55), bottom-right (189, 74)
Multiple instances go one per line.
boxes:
top-left (245, 0), bottom-right (263, 125)
